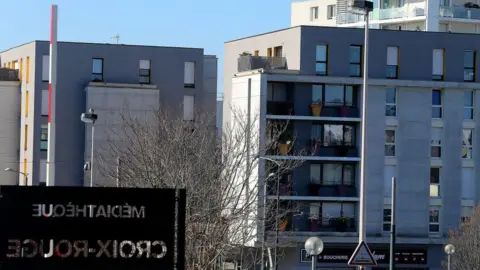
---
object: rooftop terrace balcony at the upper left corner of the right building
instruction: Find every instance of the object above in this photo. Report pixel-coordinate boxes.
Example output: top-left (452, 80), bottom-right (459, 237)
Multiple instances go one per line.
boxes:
top-left (238, 55), bottom-right (287, 72)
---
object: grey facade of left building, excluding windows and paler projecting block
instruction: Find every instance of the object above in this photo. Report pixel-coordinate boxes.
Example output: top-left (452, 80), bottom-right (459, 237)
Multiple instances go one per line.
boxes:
top-left (0, 41), bottom-right (217, 186)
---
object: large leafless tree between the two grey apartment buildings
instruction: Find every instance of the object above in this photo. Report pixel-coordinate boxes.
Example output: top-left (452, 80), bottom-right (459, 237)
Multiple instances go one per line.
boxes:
top-left (97, 107), bottom-right (302, 269)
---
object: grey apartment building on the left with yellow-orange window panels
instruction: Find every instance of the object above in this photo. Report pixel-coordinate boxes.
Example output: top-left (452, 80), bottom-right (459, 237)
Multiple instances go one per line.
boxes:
top-left (0, 41), bottom-right (217, 186)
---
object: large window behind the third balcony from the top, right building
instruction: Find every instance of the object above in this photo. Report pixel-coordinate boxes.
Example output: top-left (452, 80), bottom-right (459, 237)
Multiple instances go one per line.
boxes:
top-left (310, 163), bottom-right (355, 185)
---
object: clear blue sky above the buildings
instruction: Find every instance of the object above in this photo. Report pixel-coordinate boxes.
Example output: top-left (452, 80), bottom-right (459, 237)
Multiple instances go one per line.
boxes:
top-left (0, 0), bottom-right (293, 97)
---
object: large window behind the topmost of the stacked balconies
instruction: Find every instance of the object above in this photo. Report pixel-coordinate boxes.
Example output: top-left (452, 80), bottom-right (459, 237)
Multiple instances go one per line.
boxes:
top-left (312, 84), bottom-right (358, 107)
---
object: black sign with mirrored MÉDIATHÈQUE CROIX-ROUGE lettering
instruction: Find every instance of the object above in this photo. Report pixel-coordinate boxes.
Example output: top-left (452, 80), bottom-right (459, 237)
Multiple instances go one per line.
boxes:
top-left (0, 186), bottom-right (185, 270)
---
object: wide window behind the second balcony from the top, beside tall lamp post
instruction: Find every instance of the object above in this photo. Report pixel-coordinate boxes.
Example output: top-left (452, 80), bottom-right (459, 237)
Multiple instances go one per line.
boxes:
top-left (323, 124), bottom-right (356, 147)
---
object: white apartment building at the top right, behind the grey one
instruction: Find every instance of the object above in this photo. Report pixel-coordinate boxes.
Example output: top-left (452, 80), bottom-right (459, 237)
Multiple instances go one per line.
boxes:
top-left (291, 0), bottom-right (480, 33)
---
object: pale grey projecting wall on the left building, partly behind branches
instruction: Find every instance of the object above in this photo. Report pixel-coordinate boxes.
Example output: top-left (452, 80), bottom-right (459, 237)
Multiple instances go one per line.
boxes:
top-left (84, 83), bottom-right (160, 186)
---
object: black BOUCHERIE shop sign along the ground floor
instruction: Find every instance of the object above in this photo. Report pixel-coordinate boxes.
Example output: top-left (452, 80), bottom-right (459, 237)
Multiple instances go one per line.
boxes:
top-left (300, 247), bottom-right (427, 264)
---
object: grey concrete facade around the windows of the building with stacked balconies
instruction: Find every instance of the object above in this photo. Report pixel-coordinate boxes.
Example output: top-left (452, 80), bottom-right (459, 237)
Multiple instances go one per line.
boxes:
top-left (224, 26), bottom-right (480, 269)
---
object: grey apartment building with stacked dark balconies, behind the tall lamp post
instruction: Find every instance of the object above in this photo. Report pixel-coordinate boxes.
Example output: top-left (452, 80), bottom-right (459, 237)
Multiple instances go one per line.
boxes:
top-left (223, 26), bottom-right (480, 270)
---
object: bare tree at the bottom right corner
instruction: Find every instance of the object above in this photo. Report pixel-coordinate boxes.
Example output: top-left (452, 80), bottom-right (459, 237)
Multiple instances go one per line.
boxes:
top-left (442, 206), bottom-right (480, 270)
